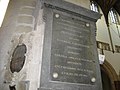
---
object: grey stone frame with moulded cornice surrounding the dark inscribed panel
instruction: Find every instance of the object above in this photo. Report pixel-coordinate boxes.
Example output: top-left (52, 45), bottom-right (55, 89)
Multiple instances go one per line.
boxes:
top-left (39, 0), bottom-right (102, 90)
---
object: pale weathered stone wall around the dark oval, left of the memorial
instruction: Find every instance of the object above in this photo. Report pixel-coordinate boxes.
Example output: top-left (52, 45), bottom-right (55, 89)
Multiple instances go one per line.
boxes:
top-left (0, 0), bottom-right (44, 90)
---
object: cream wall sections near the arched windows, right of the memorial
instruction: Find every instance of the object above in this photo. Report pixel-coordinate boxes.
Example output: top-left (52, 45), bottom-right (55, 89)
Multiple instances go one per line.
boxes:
top-left (96, 10), bottom-right (120, 74)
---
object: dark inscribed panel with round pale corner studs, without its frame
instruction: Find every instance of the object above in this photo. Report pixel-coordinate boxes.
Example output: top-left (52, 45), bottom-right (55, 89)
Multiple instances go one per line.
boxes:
top-left (50, 13), bottom-right (96, 84)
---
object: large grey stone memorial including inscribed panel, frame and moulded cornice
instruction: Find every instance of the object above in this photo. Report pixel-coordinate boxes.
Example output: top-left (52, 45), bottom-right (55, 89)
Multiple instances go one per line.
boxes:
top-left (39, 0), bottom-right (102, 90)
